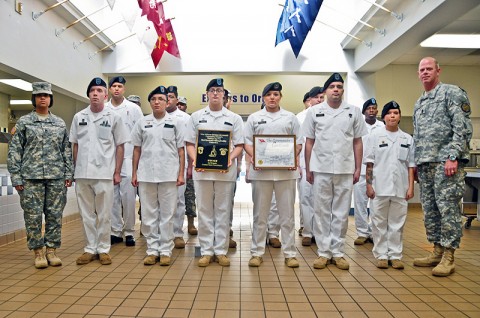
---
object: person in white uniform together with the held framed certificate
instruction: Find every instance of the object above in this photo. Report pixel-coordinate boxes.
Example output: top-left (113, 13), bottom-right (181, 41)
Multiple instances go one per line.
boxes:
top-left (245, 82), bottom-right (303, 268)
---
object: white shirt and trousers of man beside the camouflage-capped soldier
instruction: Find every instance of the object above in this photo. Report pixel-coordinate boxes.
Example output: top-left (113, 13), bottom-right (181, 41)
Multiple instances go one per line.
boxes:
top-left (70, 106), bottom-right (130, 254)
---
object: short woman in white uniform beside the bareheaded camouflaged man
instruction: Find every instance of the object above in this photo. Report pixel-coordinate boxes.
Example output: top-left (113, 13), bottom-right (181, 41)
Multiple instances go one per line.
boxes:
top-left (364, 101), bottom-right (415, 269)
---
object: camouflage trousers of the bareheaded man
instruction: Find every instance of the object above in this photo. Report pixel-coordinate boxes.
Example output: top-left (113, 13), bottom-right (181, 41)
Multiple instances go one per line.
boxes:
top-left (418, 162), bottom-right (465, 249)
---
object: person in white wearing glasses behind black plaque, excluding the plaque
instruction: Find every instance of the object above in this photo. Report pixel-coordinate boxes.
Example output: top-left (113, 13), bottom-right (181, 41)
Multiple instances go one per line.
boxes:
top-left (185, 78), bottom-right (243, 267)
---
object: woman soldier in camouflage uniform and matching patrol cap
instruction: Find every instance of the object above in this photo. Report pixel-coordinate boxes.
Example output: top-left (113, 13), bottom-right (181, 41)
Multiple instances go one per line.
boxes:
top-left (7, 82), bottom-right (73, 268)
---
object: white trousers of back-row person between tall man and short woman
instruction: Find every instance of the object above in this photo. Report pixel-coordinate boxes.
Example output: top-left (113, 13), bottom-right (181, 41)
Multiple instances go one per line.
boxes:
top-left (353, 175), bottom-right (373, 237)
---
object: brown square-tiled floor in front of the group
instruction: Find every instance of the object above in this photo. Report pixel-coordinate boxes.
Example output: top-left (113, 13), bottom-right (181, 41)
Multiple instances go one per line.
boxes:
top-left (0, 203), bottom-right (480, 318)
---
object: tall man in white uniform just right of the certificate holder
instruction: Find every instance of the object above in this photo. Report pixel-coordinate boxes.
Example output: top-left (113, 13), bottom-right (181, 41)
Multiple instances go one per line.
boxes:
top-left (302, 73), bottom-right (368, 270)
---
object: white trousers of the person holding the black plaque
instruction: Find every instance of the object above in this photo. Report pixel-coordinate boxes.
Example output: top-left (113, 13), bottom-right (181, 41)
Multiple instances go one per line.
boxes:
top-left (194, 180), bottom-right (235, 256)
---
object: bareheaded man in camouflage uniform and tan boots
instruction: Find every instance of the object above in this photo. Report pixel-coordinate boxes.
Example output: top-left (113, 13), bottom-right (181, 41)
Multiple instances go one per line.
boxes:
top-left (413, 57), bottom-right (472, 276)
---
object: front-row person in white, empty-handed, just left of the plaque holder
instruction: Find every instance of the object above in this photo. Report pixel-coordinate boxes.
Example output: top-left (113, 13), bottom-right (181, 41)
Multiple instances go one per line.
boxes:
top-left (132, 86), bottom-right (185, 266)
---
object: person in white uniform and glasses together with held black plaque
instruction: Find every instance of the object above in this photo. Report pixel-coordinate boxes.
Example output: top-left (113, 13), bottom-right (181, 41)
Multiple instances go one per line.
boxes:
top-left (185, 78), bottom-right (244, 267)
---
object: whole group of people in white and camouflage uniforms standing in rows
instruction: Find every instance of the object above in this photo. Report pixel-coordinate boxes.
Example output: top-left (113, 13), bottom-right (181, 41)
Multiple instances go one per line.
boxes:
top-left (8, 58), bottom-right (472, 276)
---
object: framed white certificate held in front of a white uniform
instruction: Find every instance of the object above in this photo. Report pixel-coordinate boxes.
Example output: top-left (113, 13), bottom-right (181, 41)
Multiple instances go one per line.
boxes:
top-left (253, 135), bottom-right (297, 169)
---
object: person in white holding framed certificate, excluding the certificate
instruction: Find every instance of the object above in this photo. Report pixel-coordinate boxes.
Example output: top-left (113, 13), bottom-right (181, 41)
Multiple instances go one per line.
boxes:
top-left (245, 82), bottom-right (303, 268)
